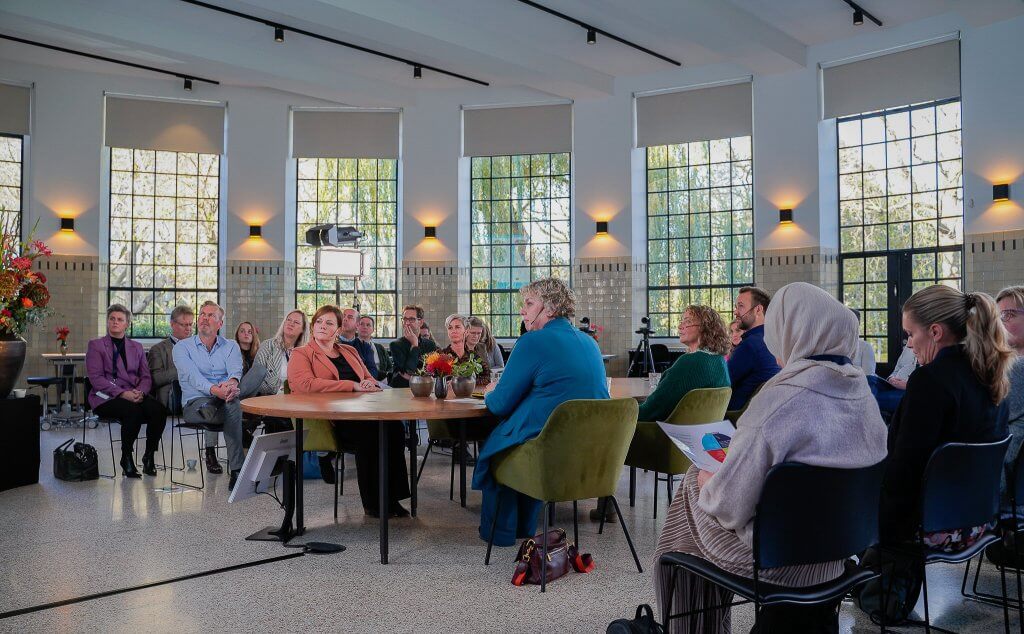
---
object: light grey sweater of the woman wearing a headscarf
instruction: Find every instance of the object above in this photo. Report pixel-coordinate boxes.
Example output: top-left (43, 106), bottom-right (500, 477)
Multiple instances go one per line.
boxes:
top-left (699, 362), bottom-right (887, 547)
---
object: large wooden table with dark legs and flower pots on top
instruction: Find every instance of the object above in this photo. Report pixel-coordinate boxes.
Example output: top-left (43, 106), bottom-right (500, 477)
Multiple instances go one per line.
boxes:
top-left (242, 378), bottom-right (650, 563)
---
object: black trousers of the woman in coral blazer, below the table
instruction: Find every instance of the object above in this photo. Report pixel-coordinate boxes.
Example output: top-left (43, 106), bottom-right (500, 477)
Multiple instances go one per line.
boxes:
top-left (334, 421), bottom-right (412, 512)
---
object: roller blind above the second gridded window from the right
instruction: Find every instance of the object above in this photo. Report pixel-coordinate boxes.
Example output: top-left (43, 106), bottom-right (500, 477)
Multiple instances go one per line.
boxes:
top-left (637, 82), bottom-right (753, 147)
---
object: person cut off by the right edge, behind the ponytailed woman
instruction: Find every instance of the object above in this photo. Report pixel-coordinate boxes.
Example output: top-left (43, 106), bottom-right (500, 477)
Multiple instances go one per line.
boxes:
top-left (996, 286), bottom-right (1024, 516)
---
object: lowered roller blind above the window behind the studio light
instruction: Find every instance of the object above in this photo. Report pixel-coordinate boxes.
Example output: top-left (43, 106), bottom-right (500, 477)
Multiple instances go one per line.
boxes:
top-left (292, 111), bottom-right (399, 159)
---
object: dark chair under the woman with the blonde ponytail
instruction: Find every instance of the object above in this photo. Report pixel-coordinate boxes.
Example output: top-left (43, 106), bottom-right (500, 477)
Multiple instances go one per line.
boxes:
top-left (901, 436), bottom-right (1010, 633)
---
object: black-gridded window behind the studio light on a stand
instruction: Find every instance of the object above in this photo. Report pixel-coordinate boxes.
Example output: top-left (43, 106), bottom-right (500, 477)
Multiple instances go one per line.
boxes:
top-left (295, 158), bottom-right (398, 338)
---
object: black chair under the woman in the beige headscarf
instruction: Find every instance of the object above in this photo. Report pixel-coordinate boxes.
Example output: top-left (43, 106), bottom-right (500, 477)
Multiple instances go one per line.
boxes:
top-left (659, 461), bottom-right (885, 630)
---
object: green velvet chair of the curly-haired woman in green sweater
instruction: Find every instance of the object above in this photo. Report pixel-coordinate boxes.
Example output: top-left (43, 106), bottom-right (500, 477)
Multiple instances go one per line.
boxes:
top-left (626, 387), bottom-right (732, 519)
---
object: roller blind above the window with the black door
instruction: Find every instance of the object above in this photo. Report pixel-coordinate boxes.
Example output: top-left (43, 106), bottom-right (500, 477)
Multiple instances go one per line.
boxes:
top-left (821, 40), bottom-right (959, 119)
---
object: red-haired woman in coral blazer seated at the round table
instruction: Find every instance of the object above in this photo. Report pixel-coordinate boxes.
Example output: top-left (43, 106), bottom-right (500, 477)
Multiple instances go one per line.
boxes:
top-left (288, 306), bottom-right (410, 517)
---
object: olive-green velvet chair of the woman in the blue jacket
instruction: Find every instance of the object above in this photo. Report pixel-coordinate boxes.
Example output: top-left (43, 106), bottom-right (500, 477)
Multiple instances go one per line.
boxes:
top-left (483, 398), bottom-right (643, 591)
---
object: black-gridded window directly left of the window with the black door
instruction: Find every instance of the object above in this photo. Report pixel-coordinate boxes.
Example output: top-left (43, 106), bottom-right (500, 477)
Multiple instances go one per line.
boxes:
top-left (646, 136), bottom-right (754, 337)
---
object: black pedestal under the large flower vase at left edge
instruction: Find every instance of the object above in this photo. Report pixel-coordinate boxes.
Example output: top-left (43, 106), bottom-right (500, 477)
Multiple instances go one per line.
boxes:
top-left (0, 394), bottom-right (41, 491)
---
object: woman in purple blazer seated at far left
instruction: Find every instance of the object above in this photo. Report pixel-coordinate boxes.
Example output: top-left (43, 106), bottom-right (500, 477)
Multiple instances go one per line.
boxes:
top-left (85, 304), bottom-right (167, 477)
